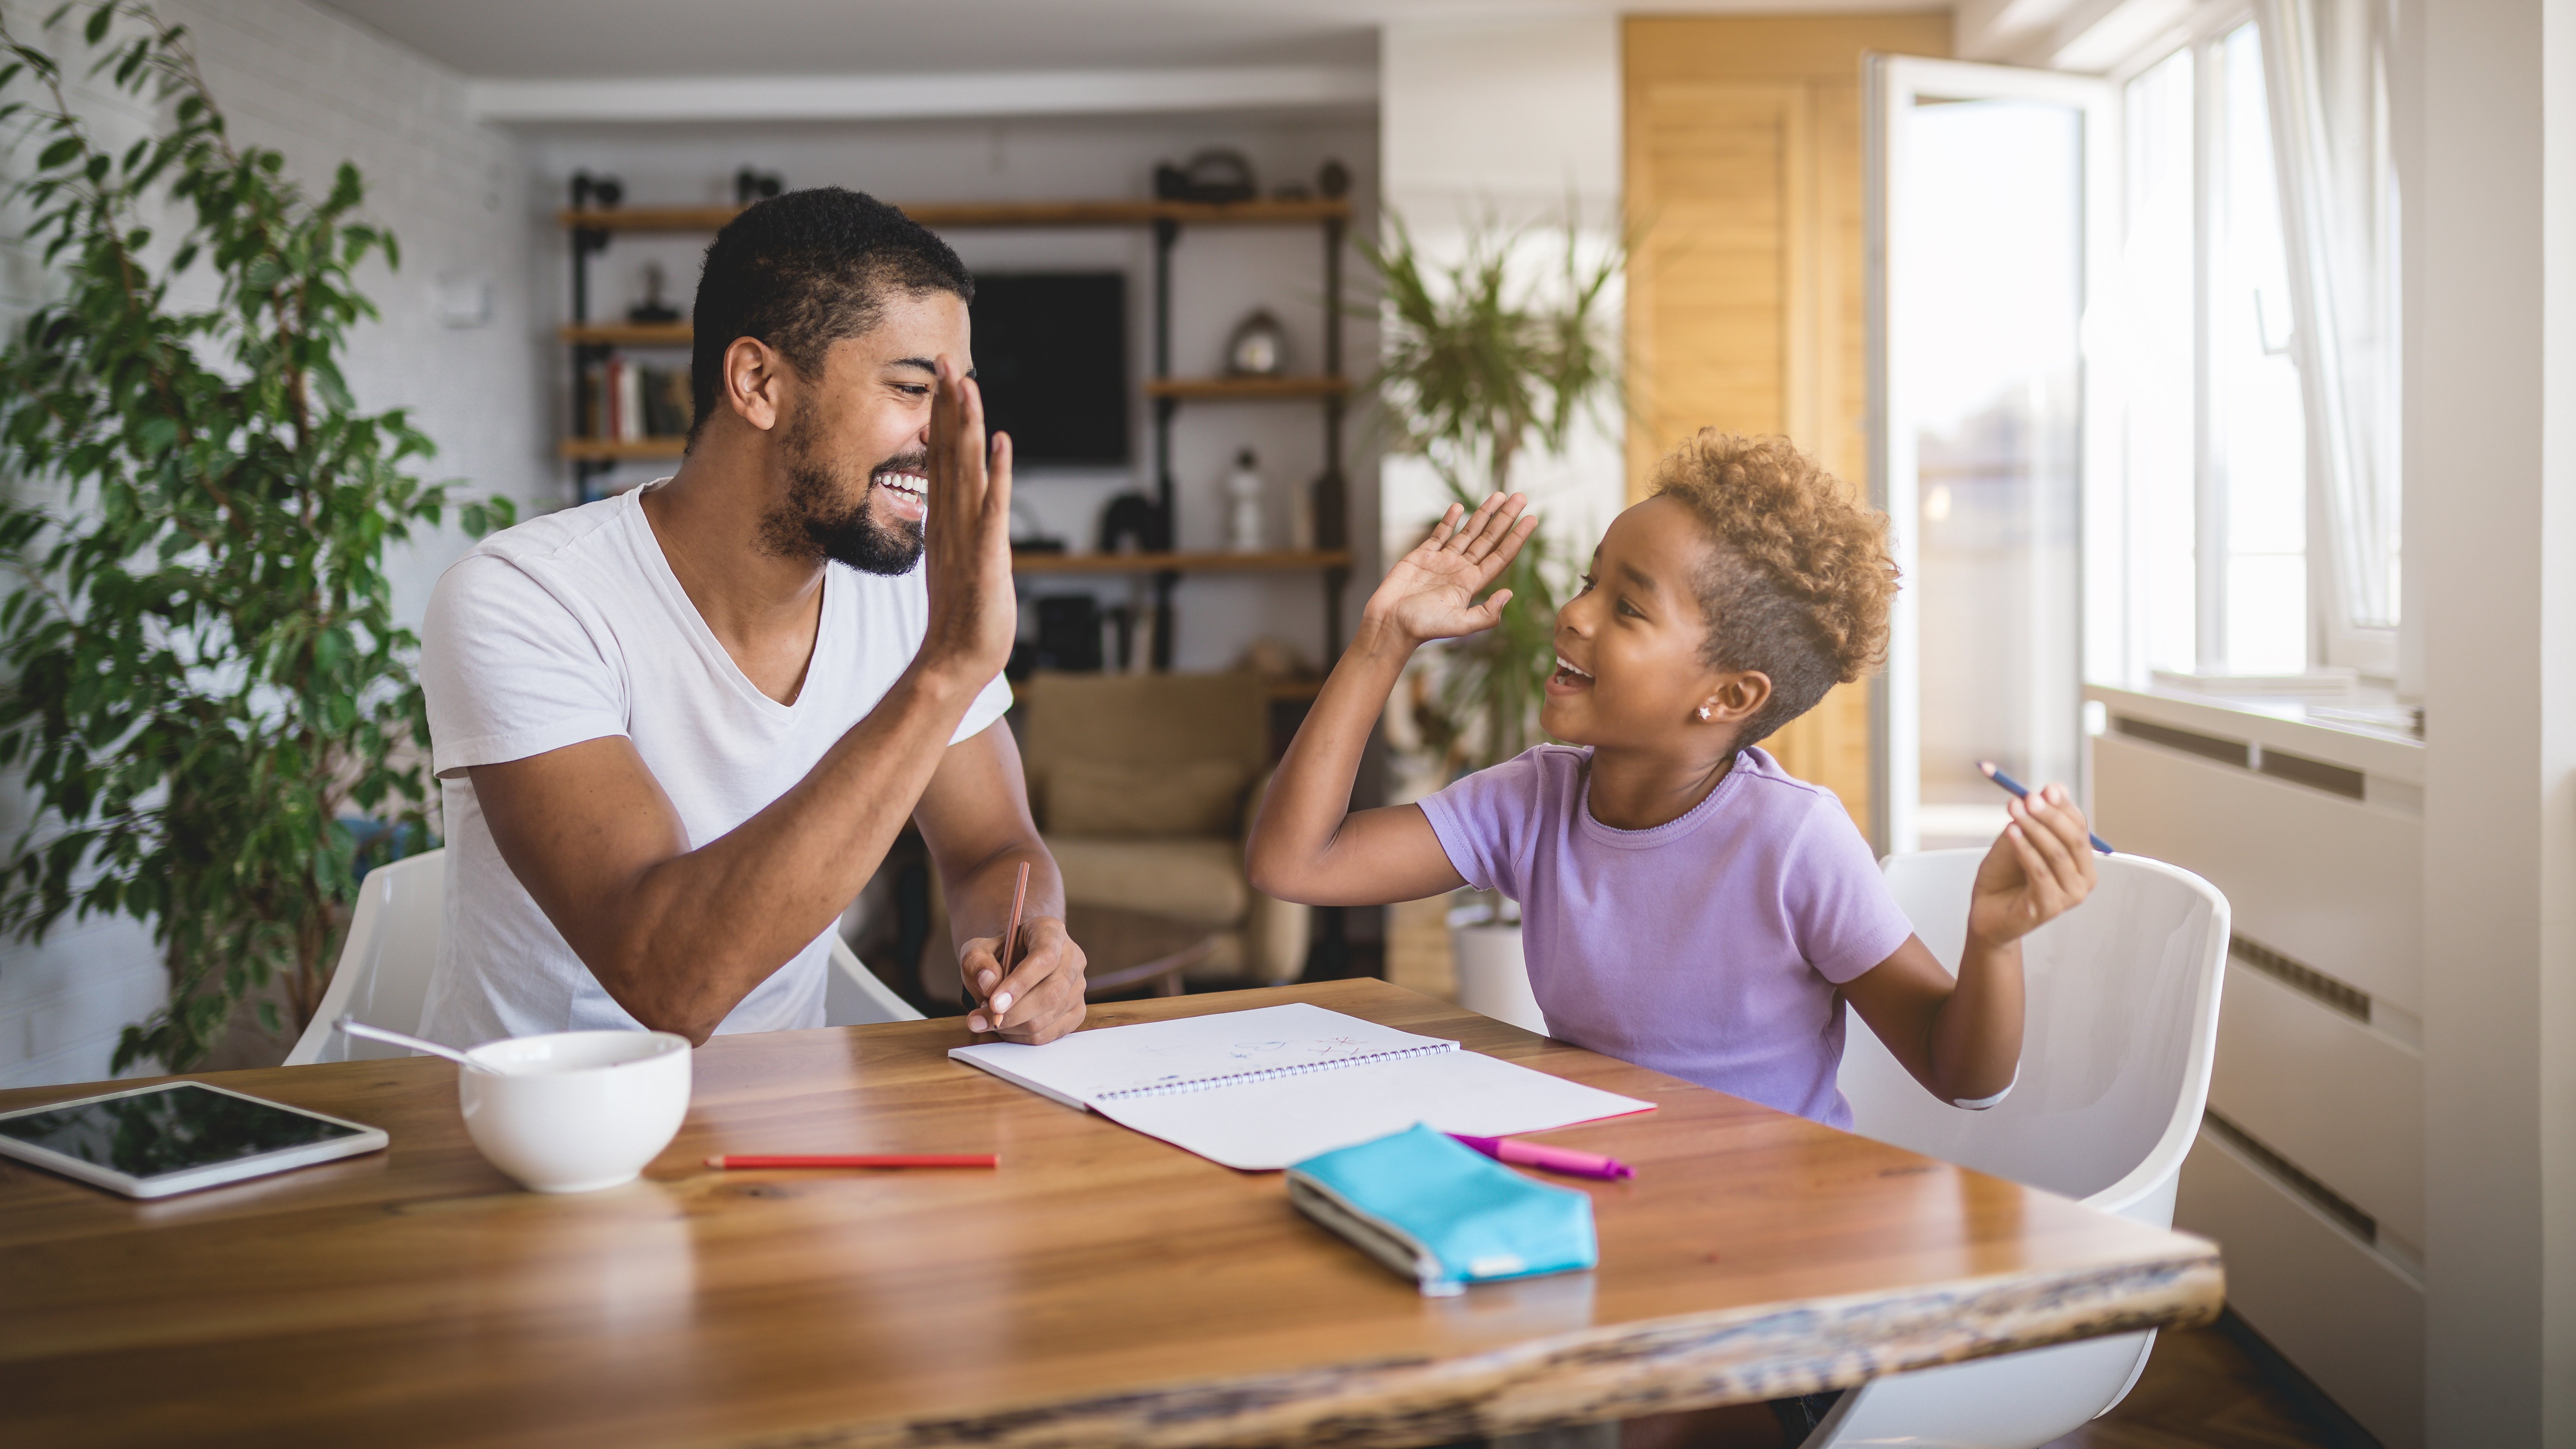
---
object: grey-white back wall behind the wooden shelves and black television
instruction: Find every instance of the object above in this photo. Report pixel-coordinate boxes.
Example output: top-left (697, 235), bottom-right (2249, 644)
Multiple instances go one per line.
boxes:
top-left (513, 113), bottom-right (1378, 670)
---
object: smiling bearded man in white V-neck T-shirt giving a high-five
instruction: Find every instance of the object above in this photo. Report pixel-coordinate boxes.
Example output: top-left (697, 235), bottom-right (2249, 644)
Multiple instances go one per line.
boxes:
top-left (420, 188), bottom-right (1084, 1047)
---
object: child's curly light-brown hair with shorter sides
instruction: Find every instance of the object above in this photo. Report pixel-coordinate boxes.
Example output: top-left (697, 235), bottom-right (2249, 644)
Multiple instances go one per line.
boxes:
top-left (1654, 428), bottom-right (1896, 745)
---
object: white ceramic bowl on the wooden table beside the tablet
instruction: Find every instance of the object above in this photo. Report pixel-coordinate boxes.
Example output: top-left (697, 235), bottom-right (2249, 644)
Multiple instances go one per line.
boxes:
top-left (456, 1031), bottom-right (688, 1191)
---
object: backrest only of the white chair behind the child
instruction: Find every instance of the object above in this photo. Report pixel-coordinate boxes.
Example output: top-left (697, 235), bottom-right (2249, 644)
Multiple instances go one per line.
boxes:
top-left (1839, 851), bottom-right (2228, 1217)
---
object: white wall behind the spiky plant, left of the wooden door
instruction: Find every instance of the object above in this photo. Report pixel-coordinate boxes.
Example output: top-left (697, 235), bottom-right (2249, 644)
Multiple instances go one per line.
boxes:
top-left (1378, 15), bottom-right (1625, 621)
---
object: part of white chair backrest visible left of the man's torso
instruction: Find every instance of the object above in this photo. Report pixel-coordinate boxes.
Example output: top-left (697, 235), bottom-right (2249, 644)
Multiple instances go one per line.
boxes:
top-left (286, 848), bottom-right (448, 1068)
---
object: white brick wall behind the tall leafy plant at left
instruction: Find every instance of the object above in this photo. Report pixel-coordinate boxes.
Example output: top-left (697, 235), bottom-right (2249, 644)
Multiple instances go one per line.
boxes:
top-left (0, 0), bottom-right (543, 1086)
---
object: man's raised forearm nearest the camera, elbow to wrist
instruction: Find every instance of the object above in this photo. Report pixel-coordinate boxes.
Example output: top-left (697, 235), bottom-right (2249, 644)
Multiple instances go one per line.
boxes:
top-left (603, 660), bottom-right (1007, 1042)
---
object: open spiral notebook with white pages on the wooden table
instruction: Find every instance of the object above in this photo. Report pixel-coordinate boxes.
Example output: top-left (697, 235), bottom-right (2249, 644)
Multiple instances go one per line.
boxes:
top-left (948, 1003), bottom-right (1654, 1173)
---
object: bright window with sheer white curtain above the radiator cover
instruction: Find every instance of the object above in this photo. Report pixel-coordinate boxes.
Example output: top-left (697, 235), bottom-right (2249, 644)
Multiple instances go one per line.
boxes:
top-left (2089, 0), bottom-right (2398, 683)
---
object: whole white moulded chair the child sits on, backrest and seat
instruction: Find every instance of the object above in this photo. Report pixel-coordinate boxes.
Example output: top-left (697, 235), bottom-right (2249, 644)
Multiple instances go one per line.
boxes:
top-left (1803, 851), bottom-right (2228, 1449)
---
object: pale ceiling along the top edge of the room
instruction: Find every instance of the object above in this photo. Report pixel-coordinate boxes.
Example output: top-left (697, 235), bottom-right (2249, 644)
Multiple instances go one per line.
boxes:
top-left (319, 0), bottom-right (1916, 80)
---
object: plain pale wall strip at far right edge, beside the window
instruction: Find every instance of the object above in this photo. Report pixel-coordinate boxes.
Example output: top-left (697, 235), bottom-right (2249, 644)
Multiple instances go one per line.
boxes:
top-left (2393, 0), bottom-right (2576, 1446)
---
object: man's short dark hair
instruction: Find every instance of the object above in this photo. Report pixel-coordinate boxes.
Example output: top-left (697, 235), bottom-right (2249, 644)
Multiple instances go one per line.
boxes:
top-left (688, 186), bottom-right (974, 441)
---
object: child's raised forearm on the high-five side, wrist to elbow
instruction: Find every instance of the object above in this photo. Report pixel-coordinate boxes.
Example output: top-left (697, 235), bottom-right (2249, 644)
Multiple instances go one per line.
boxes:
top-left (1244, 616), bottom-right (1414, 900)
